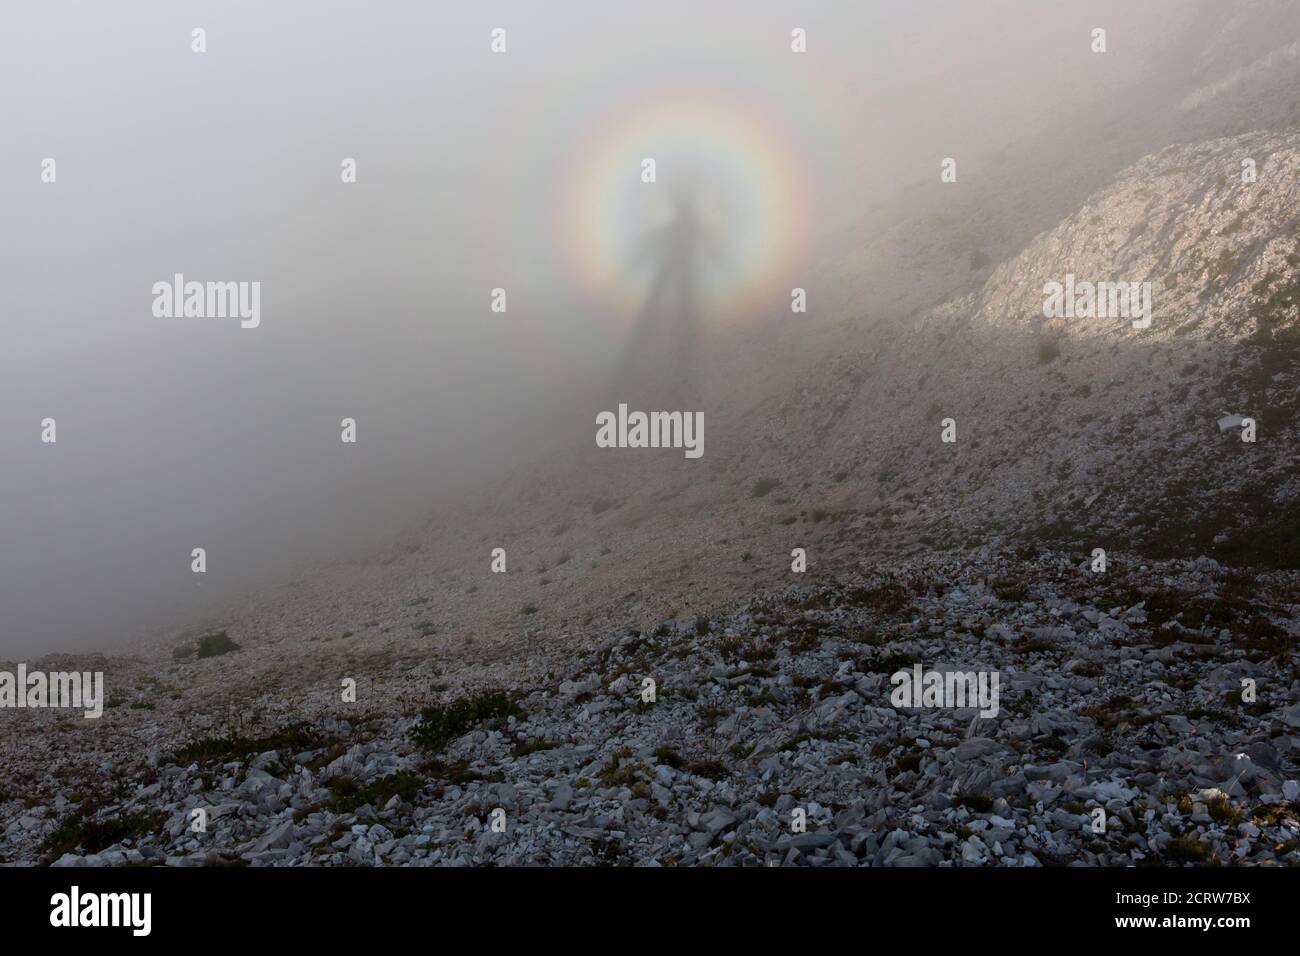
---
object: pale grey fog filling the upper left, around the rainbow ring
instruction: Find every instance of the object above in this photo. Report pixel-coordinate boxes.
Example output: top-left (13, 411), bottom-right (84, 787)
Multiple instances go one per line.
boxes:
top-left (0, 0), bottom-right (1258, 654)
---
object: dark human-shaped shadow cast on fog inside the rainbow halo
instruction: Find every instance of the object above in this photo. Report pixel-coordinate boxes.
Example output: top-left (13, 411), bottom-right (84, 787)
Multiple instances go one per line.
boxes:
top-left (612, 195), bottom-right (716, 411)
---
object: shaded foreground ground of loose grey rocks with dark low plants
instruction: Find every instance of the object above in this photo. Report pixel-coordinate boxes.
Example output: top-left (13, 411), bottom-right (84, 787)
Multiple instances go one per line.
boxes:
top-left (0, 551), bottom-right (1300, 866)
